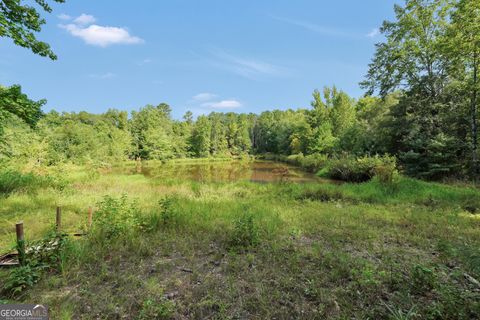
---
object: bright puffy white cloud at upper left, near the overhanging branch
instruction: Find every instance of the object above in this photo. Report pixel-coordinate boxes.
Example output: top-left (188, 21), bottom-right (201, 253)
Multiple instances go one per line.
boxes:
top-left (60, 23), bottom-right (144, 47)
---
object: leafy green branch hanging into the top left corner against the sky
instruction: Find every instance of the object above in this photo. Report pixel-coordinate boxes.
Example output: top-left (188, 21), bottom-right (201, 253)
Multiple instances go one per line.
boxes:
top-left (0, 0), bottom-right (65, 60)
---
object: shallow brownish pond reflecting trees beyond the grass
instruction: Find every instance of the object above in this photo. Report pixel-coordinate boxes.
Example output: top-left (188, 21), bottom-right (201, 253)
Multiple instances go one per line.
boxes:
top-left (116, 160), bottom-right (323, 183)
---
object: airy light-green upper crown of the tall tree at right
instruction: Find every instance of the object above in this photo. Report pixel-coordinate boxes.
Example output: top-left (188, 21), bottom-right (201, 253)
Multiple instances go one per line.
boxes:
top-left (361, 0), bottom-right (451, 97)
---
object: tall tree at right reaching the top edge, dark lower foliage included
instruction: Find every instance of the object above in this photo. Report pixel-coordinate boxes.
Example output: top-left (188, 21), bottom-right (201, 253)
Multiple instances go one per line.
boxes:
top-left (361, 0), bottom-right (457, 178)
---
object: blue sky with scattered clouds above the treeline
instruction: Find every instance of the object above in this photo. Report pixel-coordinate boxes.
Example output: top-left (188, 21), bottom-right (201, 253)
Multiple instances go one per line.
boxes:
top-left (0, 0), bottom-right (400, 118)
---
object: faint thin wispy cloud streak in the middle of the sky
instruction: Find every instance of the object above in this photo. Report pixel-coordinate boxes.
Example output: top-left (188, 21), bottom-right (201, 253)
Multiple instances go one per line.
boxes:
top-left (211, 49), bottom-right (288, 79)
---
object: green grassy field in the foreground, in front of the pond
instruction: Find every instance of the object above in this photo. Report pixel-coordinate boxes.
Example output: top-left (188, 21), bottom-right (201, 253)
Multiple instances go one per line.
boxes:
top-left (0, 161), bottom-right (480, 319)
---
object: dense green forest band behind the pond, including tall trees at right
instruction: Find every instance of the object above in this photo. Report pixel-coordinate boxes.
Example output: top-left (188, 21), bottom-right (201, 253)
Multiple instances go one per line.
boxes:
top-left (0, 0), bottom-right (480, 179)
